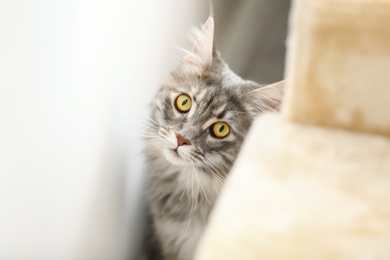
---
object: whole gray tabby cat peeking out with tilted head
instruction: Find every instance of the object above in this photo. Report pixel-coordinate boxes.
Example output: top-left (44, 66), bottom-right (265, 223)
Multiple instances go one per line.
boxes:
top-left (145, 17), bottom-right (283, 260)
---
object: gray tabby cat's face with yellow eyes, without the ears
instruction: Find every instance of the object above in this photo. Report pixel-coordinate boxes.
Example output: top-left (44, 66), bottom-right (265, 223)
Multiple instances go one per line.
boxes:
top-left (153, 72), bottom-right (252, 176)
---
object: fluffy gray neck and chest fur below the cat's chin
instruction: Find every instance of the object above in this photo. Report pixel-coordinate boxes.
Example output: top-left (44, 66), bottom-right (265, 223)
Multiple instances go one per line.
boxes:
top-left (148, 146), bottom-right (222, 259)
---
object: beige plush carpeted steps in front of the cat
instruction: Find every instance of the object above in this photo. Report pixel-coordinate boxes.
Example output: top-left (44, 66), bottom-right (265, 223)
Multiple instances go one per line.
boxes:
top-left (196, 0), bottom-right (390, 260)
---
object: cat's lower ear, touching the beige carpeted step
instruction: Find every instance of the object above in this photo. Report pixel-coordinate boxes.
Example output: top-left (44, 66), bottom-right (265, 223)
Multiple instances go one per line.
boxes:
top-left (244, 80), bottom-right (286, 116)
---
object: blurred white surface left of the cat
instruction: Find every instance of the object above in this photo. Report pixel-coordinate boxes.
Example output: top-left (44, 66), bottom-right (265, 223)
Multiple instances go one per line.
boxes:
top-left (0, 0), bottom-right (204, 260)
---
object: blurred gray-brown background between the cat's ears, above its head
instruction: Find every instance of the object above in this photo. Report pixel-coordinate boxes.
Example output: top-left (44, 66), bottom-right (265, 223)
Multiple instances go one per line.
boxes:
top-left (213, 0), bottom-right (291, 83)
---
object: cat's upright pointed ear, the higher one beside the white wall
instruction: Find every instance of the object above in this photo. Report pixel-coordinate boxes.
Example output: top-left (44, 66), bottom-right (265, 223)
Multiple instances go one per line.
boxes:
top-left (183, 17), bottom-right (214, 68)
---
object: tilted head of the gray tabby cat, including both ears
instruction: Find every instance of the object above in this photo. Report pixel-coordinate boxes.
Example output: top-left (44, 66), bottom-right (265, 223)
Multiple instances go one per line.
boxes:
top-left (148, 17), bottom-right (283, 175)
